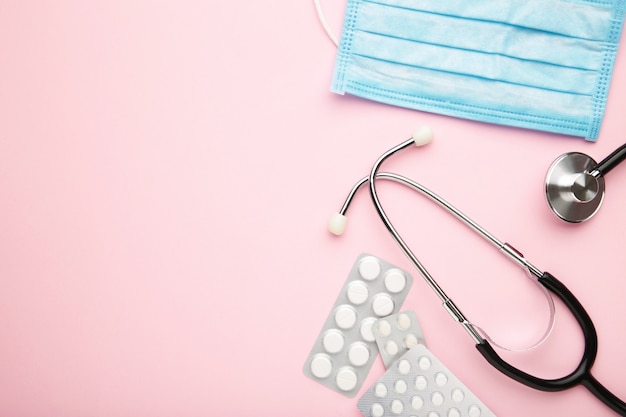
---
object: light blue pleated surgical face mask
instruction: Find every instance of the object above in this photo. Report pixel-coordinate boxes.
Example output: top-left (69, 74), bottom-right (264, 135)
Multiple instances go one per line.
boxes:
top-left (331, 0), bottom-right (626, 141)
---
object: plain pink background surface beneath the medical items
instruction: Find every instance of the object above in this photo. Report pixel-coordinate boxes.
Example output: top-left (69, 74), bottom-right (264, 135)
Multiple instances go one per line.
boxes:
top-left (0, 0), bottom-right (626, 417)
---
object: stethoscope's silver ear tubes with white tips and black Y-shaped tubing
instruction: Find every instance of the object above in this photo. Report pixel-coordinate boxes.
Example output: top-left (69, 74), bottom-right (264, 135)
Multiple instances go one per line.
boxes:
top-left (328, 128), bottom-right (626, 416)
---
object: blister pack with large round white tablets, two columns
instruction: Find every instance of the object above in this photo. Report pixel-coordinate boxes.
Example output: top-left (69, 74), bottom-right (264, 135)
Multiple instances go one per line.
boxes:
top-left (304, 254), bottom-right (413, 397)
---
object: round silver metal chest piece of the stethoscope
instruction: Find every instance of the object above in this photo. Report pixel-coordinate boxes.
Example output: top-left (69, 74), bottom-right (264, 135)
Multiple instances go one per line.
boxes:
top-left (546, 152), bottom-right (604, 223)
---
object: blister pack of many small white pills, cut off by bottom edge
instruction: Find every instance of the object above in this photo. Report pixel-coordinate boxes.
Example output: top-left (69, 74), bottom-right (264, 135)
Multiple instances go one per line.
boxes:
top-left (357, 345), bottom-right (495, 417)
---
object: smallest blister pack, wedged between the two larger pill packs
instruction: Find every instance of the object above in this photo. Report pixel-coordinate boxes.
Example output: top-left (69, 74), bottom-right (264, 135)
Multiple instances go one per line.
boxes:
top-left (373, 311), bottom-right (426, 369)
